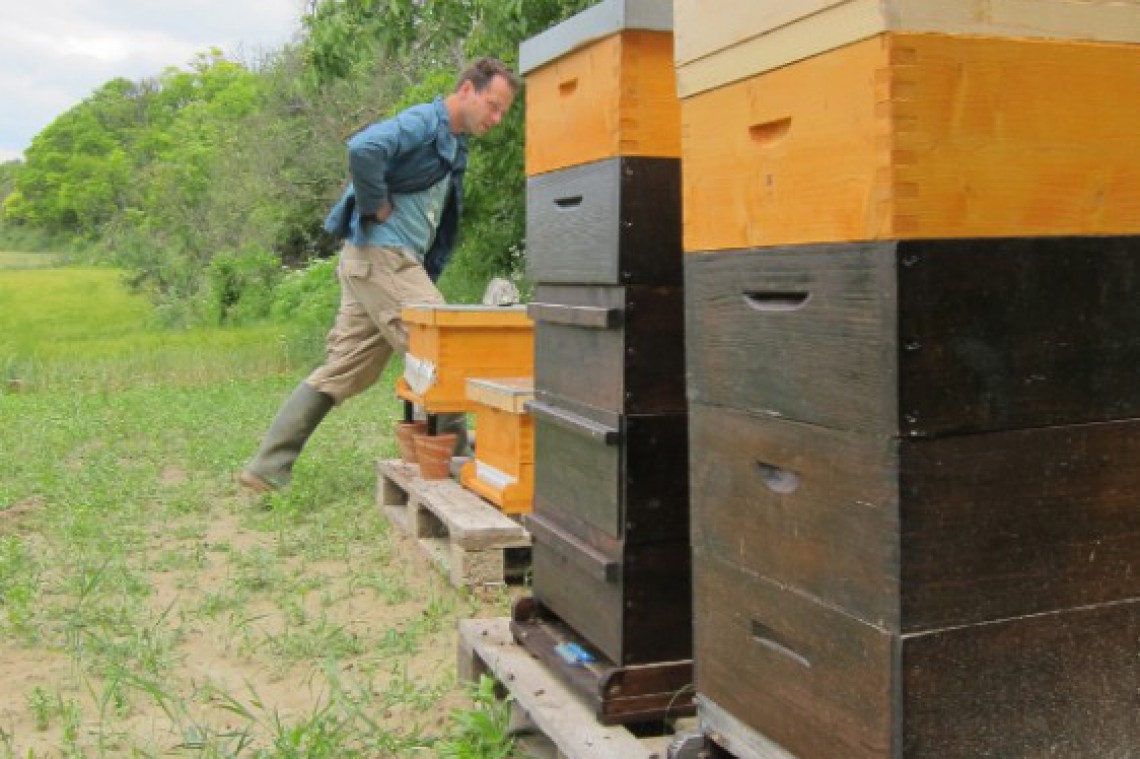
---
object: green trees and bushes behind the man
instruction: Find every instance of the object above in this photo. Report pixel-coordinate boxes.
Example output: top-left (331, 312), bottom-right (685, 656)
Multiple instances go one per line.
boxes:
top-left (0, 0), bottom-right (593, 323)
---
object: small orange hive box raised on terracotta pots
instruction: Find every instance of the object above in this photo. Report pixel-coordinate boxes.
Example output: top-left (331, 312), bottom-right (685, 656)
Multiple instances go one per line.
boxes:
top-left (396, 304), bottom-right (535, 414)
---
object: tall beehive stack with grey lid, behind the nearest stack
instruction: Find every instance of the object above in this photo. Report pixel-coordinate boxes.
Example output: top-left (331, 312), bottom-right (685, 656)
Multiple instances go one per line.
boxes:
top-left (515, 0), bottom-right (692, 721)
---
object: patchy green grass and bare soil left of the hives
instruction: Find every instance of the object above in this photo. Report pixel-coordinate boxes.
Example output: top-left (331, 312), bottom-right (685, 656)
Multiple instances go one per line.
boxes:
top-left (0, 262), bottom-right (519, 759)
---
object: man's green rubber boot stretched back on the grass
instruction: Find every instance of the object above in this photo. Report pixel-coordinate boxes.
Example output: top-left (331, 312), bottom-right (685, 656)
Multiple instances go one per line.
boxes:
top-left (237, 382), bottom-right (333, 492)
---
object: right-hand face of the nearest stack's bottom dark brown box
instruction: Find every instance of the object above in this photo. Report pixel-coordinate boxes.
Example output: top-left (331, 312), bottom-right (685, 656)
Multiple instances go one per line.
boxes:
top-left (898, 601), bottom-right (1140, 759)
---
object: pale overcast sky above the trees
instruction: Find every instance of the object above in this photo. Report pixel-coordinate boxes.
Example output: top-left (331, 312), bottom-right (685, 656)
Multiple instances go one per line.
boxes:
top-left (0, 0), bottom-right (306, 162)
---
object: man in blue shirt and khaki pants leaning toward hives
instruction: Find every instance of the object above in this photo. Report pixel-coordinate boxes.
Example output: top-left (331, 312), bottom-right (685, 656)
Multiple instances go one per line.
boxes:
top-left (238, 58), bottom-right (519, 492)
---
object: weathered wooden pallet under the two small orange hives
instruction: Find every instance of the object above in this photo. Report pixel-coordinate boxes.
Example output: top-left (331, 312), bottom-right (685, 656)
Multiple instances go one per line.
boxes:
top-left (376, 460), bottom-right (530, 587)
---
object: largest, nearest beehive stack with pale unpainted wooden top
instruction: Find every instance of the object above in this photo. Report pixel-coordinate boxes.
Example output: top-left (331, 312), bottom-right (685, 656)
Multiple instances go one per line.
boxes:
top-left (675, 0), bottom-right (1140, 759)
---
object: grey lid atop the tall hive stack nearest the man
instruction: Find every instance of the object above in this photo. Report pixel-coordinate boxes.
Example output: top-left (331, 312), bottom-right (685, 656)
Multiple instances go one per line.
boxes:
top-left (519, 0), bottom-right (673, 74)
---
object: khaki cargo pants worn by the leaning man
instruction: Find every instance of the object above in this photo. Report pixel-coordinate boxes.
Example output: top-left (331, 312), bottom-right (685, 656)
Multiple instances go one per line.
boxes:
top-left (306, 243), bottom-right (445, 406)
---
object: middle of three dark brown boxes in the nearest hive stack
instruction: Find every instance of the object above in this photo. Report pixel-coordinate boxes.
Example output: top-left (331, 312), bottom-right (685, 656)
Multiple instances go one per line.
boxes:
top-left (690, 405), bottom-right (1140, 633)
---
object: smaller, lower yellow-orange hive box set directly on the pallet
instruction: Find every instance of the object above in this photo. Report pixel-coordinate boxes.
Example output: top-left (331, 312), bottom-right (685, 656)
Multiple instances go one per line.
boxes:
top-left (459, 377), bottom-right (535, 514)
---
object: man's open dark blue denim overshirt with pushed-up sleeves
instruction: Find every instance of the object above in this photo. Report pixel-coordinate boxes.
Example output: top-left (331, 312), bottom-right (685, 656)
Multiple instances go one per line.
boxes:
top-left (325, 97), bottom-right (467, 281)
